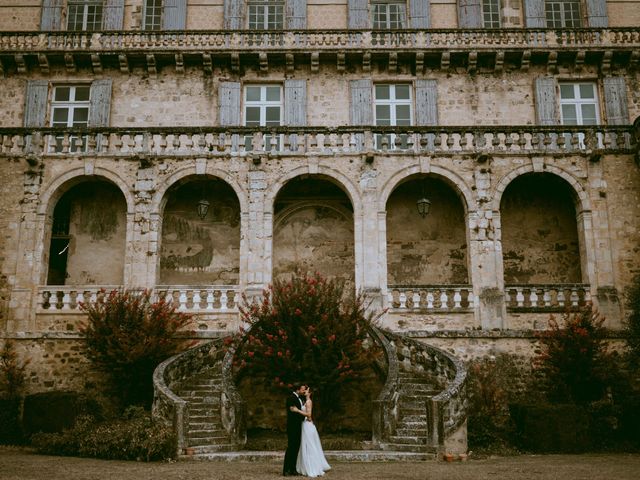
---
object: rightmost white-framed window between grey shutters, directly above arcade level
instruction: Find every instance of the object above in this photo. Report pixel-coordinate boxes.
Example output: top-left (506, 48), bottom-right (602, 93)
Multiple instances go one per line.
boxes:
top-left (560, 83), bottom-right (600, 125)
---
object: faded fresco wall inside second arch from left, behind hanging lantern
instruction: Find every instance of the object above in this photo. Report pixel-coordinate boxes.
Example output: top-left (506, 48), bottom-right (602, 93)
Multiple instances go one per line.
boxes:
top-left (159, 180), bottom-right (240, 285)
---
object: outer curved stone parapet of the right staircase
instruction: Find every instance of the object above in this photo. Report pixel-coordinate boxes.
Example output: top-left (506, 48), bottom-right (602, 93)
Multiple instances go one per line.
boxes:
top-left (384, 330), bottom-right (468, 450)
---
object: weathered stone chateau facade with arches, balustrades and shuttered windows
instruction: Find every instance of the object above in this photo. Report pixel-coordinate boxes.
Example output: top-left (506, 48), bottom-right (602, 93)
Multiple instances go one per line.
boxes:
top-left (0, 0), bottom-right (640, 398)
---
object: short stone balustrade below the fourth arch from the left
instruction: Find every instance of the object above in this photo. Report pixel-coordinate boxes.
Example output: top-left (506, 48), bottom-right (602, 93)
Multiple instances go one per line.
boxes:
top-left (387, 285), bottom-right (475, 312)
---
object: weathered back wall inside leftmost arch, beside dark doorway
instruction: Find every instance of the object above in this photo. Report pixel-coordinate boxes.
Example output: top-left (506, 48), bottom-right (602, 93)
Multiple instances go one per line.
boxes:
top-left (62, 182), bottom-right (127, 285)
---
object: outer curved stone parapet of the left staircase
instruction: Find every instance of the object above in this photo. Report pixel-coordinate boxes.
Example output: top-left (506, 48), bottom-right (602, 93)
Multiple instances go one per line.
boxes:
top-left (152, 339), bottom-right (224, 455)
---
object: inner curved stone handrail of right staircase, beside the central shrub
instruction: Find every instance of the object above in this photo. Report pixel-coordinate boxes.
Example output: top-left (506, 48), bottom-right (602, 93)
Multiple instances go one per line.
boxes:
top-left (369, 325), bottom-right (400, 444)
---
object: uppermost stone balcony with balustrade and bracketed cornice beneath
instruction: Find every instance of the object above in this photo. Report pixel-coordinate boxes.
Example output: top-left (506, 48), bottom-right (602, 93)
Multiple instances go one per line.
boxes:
top-left (0, 28), bottom-right (640, 74)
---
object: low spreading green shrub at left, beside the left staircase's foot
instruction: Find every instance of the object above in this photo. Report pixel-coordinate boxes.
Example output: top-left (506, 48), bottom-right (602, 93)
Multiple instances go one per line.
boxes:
top-left (32, 407), bottom-right (176, 462)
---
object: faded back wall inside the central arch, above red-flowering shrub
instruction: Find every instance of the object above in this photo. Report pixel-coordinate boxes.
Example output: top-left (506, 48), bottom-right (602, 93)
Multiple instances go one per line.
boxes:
top-left (273, 179), bottom-right (355, 283)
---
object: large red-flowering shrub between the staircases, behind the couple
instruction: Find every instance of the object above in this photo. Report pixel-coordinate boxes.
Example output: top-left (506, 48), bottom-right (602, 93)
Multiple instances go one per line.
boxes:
top-left (230, 273), bottom-right (379, 421)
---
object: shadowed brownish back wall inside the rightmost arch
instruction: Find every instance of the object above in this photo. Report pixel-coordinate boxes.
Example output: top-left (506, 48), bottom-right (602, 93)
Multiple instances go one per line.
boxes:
top-left (500, 174), bottom-right (582, 284)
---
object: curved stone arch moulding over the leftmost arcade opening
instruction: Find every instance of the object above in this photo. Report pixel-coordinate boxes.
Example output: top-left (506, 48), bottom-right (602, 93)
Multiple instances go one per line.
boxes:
top-left (38, 167), bottom-right (135, 215)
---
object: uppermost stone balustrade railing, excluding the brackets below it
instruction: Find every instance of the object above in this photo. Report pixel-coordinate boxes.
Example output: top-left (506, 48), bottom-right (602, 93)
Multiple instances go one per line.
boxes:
top-left (0, 28), bottom-right (640, 54)
